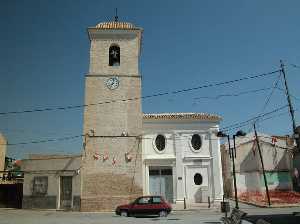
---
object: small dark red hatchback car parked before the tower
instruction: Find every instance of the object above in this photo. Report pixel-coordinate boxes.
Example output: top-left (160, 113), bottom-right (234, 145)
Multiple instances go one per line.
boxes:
top-left (116, 196), bottom-right (172, 217)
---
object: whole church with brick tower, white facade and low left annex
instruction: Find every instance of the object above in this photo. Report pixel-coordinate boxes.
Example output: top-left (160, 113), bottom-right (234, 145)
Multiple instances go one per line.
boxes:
top-left (22, 19), bottom-right (223, 211)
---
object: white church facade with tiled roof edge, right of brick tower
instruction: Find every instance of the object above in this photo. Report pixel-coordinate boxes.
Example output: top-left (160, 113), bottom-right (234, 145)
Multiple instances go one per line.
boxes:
top-left (142, 113), bottom-right (223, 206)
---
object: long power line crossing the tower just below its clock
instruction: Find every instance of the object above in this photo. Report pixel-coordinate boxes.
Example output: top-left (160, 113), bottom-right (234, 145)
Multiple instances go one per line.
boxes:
top-left (0, 70), bottom-right (280, 116)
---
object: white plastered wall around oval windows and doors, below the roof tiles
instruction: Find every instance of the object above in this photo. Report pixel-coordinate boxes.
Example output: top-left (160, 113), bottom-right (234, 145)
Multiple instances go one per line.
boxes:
top-left (142, 119), bottom-right (223, 203)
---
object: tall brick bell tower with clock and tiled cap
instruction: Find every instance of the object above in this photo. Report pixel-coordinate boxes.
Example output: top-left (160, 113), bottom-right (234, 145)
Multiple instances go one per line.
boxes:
top-left (81, 19), bottom-right (142, 211)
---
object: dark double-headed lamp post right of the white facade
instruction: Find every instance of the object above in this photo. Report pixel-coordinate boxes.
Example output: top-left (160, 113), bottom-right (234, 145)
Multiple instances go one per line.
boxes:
top-left (217, 131), bottom-right (246, 209)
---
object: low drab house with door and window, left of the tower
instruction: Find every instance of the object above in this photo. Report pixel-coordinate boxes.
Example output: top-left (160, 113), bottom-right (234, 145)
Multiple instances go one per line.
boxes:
top-left (21, 155), bottom-right (81, 210)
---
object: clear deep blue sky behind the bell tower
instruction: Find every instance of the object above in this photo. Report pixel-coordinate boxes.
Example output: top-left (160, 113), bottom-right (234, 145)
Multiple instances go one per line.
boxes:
top-left (0, 0), bottom-right (300, 158)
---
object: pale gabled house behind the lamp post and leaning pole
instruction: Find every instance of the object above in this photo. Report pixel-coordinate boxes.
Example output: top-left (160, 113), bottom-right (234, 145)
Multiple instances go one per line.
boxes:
top-left (221, 133), bottom-right (294, 195)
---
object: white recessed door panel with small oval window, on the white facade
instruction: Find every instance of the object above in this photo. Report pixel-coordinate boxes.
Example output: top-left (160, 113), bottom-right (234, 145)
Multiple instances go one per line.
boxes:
top-left (185, 166), bottom-right (210, 203)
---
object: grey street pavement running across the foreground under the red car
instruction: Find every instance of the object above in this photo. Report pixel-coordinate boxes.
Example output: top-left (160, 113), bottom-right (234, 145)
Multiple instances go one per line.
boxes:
top-left (0, 201), bottom-right (300, 224)
